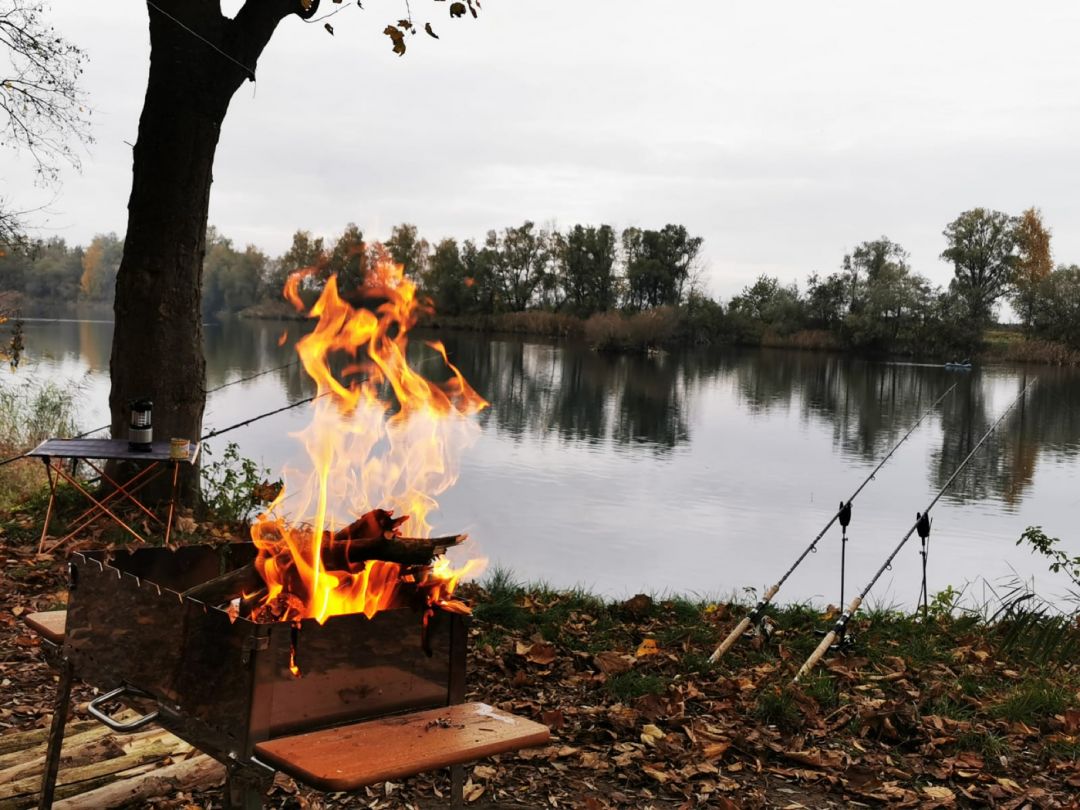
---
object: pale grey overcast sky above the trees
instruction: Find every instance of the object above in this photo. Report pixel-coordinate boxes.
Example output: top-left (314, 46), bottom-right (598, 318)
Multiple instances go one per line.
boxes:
top-left (0, 0), bottom-right (1080, 299)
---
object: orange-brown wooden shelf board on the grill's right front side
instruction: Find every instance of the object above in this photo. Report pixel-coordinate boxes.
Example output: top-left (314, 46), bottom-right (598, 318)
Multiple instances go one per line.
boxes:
top-left (255, 703), bottom-right (551, 791)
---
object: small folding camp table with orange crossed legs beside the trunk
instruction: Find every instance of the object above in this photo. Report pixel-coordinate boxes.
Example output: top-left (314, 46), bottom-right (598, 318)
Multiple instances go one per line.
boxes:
top-left (27, 438), bottom-right (200, 552)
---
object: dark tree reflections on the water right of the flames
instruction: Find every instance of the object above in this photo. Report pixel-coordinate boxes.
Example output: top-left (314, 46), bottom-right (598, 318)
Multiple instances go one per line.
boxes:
top-left (446, 336), bottom-right (1080, 508)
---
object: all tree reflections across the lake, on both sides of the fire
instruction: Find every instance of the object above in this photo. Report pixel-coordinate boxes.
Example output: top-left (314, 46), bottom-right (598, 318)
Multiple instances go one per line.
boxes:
top-left (14, 321), bottom-right (1080, 510)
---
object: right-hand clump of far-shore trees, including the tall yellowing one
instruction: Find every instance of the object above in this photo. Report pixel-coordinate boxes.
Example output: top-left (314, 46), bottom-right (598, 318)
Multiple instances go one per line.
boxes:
top-left (726, 208), bottom-right (1080, 353)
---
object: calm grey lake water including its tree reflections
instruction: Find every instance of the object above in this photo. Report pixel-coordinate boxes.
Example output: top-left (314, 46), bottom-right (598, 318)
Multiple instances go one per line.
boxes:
top-left (4, 321), bottom-right (1080, 606)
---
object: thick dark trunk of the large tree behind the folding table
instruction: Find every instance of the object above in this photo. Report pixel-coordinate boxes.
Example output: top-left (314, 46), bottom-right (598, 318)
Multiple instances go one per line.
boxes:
top-left (109, 0), bottom-right (301, 502)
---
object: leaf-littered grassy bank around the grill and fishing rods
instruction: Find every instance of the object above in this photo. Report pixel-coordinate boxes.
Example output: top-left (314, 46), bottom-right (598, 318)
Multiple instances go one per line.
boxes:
top-left (0, 494), bottom-right (1080, 810)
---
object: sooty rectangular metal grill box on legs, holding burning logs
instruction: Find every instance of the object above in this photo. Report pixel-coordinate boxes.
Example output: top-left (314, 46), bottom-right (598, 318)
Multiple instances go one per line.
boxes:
top-left (30, 543), bottom-right (548, 808)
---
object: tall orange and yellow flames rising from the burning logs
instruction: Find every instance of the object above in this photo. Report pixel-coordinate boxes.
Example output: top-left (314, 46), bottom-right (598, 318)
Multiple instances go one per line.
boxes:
top-left (252, 259), bottom-right (487, 622)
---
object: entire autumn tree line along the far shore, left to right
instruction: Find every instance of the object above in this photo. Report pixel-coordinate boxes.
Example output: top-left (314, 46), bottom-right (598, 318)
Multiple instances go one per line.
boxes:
top-left (0, 208), bottom-right (1080, 354)
